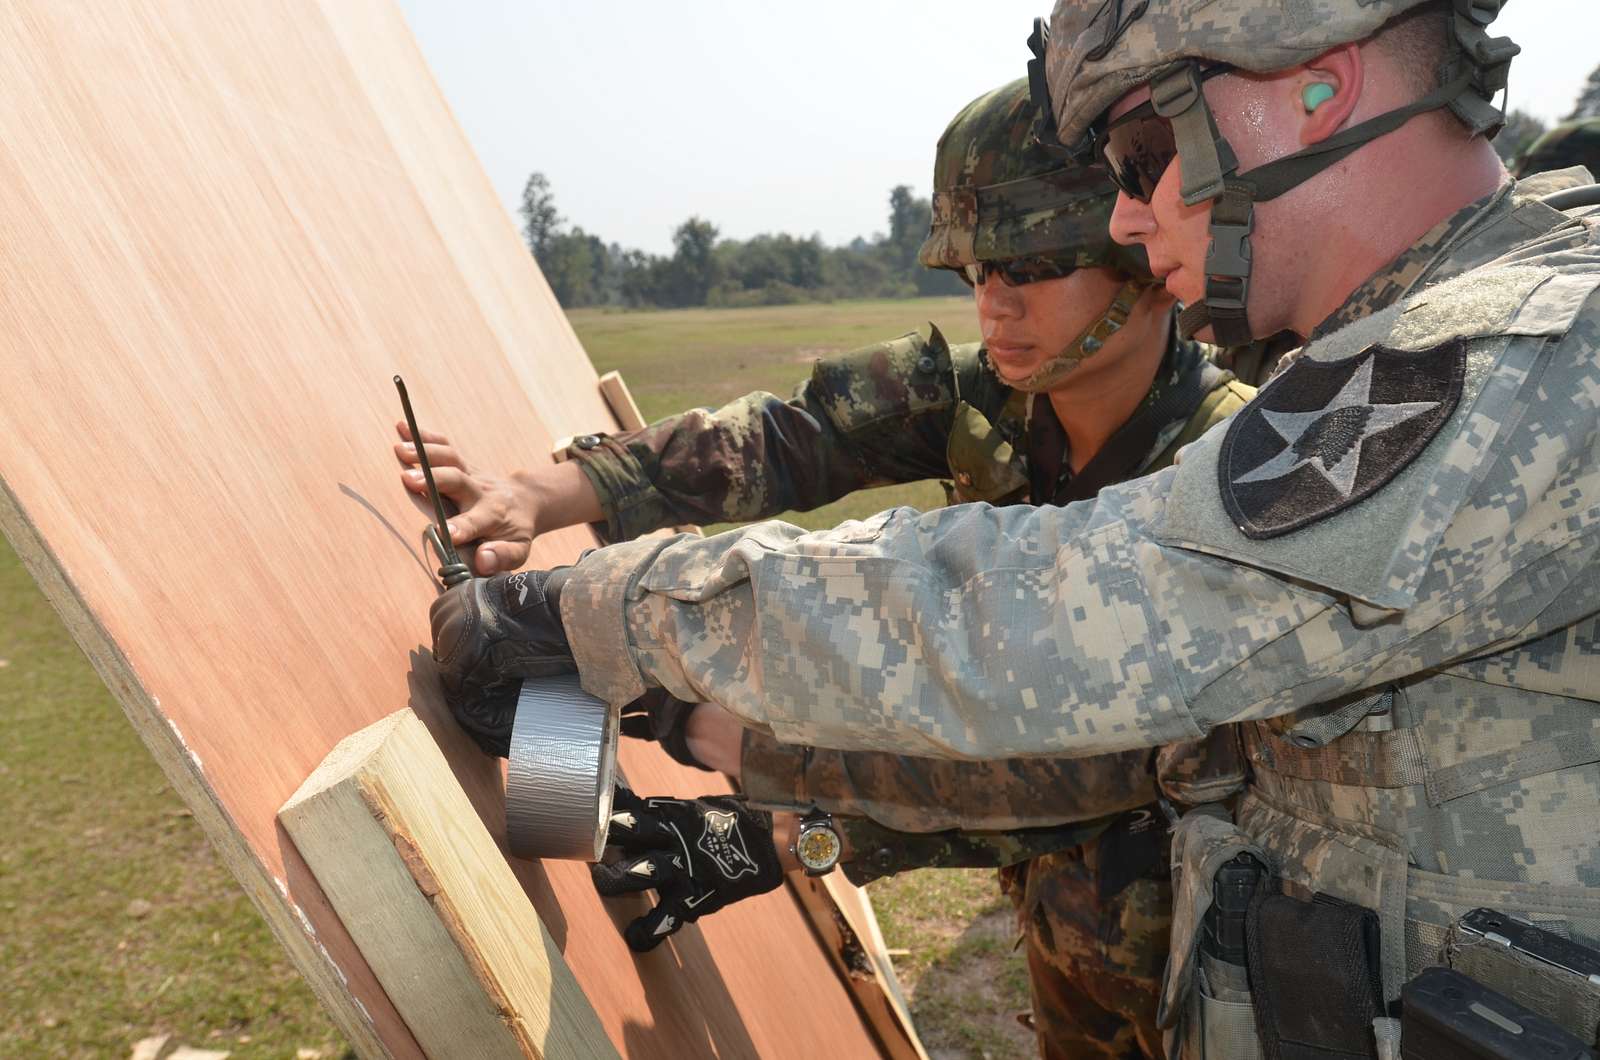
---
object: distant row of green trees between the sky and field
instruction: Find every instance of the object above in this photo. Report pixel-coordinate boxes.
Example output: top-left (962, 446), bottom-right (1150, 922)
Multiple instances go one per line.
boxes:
top-left (518, 173), bottom-right (966, 309)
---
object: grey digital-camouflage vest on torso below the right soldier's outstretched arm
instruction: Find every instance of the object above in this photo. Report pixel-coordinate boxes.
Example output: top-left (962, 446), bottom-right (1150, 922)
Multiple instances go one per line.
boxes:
top-left (1238, 620), bottom-right (1600, 999)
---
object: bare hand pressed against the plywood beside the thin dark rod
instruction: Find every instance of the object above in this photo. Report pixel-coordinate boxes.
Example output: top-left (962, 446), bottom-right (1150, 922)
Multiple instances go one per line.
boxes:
top-left (395, 423), bottom-right (539, 576)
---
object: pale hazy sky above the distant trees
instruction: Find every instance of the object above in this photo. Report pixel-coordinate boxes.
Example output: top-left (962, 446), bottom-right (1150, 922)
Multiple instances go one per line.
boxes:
top-left (400, 0), bottom-right (1600, 253)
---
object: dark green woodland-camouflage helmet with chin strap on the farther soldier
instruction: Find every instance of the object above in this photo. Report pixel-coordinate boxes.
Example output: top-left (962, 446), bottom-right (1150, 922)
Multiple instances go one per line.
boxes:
top-left (917, 78), bottom-right (1154, 392)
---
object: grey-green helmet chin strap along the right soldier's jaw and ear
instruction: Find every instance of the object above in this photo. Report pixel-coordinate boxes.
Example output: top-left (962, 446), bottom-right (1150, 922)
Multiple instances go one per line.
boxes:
top-left (1150, 0), bottom-right (1520, 346)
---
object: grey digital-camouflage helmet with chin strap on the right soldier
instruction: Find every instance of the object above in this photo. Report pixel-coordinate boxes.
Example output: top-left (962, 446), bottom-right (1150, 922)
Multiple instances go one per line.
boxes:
top-left (1040, 0), bottom-right (1520, 346)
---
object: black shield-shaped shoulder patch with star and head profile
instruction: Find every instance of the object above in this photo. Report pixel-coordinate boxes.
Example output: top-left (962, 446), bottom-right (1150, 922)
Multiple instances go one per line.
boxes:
top-left (1218, 339), bottom-right (1467, 540)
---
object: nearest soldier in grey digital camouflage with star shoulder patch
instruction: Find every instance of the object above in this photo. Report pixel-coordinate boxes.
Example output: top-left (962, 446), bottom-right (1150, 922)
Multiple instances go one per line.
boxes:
top-left (434, 0), bottom-right (1600, 1055)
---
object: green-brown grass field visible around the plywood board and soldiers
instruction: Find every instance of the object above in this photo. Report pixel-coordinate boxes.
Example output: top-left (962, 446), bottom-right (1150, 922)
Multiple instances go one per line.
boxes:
top-left (0, 298), bottom-right (1032, 1060)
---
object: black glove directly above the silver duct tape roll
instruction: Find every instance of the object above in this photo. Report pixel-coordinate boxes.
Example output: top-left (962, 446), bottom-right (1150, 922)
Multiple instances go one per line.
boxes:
top-left (427, 567), bottom-right (578, 757)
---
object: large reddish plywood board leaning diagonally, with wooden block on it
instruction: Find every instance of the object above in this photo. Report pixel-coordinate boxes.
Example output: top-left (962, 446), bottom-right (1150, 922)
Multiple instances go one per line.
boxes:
top-left (0, 0), bottom-right (874, 1057)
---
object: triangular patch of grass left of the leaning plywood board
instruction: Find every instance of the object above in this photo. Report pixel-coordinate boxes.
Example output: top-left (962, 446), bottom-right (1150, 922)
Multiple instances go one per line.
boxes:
top-left (0, 540), bottom-right (342, 1057)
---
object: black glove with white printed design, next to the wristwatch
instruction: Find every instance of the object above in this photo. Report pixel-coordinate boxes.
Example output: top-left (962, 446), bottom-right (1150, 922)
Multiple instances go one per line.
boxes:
top-left (590, 785), bottom-right (784, 953)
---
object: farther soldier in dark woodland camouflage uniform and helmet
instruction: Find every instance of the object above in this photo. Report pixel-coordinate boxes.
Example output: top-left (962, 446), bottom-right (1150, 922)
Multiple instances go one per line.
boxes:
top-left (400, 82), bottom-right (1253, 1057)
